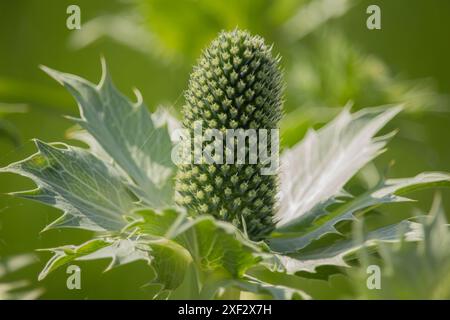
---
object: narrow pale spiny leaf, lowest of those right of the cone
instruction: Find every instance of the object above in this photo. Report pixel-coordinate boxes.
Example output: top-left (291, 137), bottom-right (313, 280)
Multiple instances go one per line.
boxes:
top-left (277, 220), bottom-right (423, 274)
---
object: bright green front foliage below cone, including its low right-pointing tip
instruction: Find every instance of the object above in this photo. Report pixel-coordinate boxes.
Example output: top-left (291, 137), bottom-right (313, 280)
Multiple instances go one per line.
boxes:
top-left (130, 210), bottom-right (308, 299)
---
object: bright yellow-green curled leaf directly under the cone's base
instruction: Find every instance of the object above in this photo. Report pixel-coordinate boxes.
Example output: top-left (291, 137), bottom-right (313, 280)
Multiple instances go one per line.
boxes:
top-left (137, 210), bottom-right (261, 277)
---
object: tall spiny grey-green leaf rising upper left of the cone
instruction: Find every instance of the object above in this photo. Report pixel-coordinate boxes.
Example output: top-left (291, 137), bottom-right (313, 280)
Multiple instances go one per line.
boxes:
top-left (43, 62), bottom-right (175, 208)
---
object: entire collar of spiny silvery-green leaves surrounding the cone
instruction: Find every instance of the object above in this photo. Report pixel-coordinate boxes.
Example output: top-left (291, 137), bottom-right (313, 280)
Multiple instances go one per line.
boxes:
top-left (1, 53), bottom-right (449, 299)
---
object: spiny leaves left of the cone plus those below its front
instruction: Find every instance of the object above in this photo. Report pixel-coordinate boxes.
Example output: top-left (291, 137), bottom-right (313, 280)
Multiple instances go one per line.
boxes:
top-left (1, 60), bottom-right (307, 298)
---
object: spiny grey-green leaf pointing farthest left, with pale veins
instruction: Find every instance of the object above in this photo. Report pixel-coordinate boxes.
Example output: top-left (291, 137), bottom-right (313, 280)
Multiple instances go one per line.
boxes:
top-left (1, 140), bottom-right (136, 231)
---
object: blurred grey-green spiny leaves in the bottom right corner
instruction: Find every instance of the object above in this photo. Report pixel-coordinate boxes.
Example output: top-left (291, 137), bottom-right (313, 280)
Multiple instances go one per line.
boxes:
top-left (350, 194), bottom-right (450, 299)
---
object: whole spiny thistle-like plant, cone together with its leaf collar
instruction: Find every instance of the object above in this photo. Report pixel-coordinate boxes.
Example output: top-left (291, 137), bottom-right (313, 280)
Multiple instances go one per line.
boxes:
top-left (1, 31), bottom-right (450, 299)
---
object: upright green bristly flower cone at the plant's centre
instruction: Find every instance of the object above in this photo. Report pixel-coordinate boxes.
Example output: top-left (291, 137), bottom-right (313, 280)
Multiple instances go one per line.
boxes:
top-left (176, 30), bottom-right (283, 240)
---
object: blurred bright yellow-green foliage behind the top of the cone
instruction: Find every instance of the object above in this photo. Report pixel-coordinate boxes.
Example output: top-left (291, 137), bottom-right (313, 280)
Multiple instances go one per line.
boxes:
top-left (70, 0), bottom-right (449, 160)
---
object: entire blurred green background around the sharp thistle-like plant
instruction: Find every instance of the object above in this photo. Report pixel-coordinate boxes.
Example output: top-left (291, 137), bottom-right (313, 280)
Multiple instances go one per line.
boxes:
top-left (0, 0), bottom-right (450, 299)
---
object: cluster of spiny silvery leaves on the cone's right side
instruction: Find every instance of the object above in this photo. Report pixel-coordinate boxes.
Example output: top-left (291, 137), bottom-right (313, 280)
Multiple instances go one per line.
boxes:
top-left (268, 107), bottom-right (450, 274)
